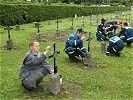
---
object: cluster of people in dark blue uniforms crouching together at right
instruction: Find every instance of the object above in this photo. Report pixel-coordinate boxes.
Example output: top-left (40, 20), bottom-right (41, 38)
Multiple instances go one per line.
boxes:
top-left (96, 18), bottom-right (133, 56)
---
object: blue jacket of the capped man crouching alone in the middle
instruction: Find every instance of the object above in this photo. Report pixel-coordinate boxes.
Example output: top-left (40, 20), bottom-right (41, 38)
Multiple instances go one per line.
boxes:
top-left (65, 32), bottom-right (83, 49)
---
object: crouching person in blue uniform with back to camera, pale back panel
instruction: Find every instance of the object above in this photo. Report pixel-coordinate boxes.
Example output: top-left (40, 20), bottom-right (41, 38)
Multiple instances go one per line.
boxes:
top-left (106, 31), bottom-right (124, 56)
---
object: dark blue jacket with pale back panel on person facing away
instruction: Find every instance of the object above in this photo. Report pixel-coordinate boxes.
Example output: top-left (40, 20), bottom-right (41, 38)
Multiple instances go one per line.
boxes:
top-left (107, 34), bottom-right (124, 52)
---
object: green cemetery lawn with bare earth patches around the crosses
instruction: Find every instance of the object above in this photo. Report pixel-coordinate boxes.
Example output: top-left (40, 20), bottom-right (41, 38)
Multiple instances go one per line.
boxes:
top-left (0, 10), bottom-right (133, 100)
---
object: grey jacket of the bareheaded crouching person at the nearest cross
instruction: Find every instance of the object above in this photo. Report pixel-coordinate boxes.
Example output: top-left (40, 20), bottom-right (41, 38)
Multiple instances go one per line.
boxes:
top-left (20, 51), bottom-right (52, 88)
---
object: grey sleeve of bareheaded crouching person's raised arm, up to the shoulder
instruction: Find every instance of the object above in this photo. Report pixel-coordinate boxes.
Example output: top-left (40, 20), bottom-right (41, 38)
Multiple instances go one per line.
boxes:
top-left (23, 53), bottom-right (46, 66)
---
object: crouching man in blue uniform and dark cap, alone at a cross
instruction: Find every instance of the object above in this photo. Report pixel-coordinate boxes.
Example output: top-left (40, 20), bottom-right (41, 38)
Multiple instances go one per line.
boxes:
top-left (65, 28), bottom-right (86, 60)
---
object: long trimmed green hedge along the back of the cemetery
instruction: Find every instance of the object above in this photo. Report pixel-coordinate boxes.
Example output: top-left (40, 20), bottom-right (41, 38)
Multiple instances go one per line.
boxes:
top-left (0, 4), bottom-right (128, 26)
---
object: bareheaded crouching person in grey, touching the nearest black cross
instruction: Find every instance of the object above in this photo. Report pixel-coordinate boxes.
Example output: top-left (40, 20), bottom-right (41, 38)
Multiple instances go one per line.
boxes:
top-left (20, 41), bottom-right (54, 91)
